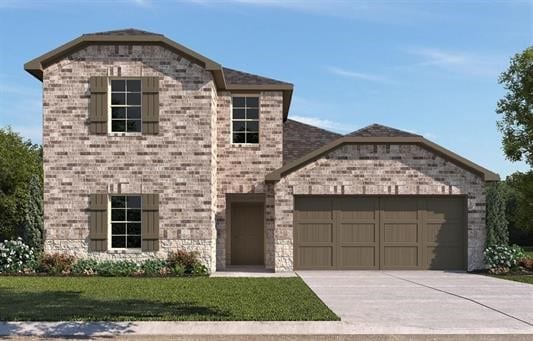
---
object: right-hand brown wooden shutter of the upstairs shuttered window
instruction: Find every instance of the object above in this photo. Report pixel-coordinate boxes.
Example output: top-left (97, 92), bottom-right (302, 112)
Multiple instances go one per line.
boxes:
top-left (142, 77), bottom-right (159, 135)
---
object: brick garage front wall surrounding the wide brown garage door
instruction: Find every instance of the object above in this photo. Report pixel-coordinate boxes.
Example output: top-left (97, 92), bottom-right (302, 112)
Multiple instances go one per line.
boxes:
top-left (274, 144), bottom-right (486, 271)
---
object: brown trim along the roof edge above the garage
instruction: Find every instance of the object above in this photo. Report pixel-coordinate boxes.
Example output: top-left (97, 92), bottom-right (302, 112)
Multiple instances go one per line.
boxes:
top-left (265, 126), bottom-right (500, 182)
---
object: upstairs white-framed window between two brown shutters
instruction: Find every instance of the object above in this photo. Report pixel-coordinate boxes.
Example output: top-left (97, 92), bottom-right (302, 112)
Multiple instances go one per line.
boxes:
top-left (111, 79), bottom-right (141, 133)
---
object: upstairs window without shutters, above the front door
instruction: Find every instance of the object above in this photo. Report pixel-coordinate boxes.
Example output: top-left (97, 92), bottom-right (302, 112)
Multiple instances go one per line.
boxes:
top-left (232, 96), bottom-right (259, 143)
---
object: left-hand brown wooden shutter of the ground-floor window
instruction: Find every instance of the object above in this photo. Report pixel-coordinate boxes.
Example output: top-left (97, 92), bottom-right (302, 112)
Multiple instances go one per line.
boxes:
top-left (89, 194), bottom-right (108, 251)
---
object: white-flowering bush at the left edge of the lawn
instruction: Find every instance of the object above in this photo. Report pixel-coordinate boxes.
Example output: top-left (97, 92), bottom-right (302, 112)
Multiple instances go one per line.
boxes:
top-left (0, 238), bottom-right (38, 273)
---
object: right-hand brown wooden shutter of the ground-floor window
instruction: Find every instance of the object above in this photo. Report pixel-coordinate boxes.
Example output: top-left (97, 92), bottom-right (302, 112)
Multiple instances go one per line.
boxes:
top-left (141, 194), bottom-right (159, 251)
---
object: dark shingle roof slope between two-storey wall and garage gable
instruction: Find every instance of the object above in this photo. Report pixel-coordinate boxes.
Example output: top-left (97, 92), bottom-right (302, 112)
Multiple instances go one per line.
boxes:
top-left (283, 119), bottom-right (341, 164)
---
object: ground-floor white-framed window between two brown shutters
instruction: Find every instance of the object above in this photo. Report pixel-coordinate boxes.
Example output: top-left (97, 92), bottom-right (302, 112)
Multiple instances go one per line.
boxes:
top-left (111, 195), bottom-right (141, 249)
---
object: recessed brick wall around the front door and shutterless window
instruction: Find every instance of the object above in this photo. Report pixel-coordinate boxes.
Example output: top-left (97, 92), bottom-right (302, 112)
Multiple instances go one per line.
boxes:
top-left (216, 91), bottom-right (283, 269)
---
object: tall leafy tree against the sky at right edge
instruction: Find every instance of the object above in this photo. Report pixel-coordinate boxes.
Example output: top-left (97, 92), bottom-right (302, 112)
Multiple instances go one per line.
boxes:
top-left (496, 46), bottom-right (533, 166)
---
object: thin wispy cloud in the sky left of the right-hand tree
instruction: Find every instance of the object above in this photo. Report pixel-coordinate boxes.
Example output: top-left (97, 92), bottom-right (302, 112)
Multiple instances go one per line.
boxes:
top-left (399, 47), bottom-right (506, 77)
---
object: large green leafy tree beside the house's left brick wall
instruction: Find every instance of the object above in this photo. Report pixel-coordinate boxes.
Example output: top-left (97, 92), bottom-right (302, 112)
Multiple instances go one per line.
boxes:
top-left (0, 128), bottom-right (43, 246)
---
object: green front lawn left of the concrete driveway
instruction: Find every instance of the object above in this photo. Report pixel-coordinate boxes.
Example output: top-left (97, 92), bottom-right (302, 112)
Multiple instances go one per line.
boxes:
top-left (0, 276), bottom-right (339, 321)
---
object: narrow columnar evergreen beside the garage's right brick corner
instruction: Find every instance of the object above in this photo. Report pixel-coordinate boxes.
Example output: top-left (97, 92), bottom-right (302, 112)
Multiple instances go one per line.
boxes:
top-left (486, 183), bottom-right (509, 246)
